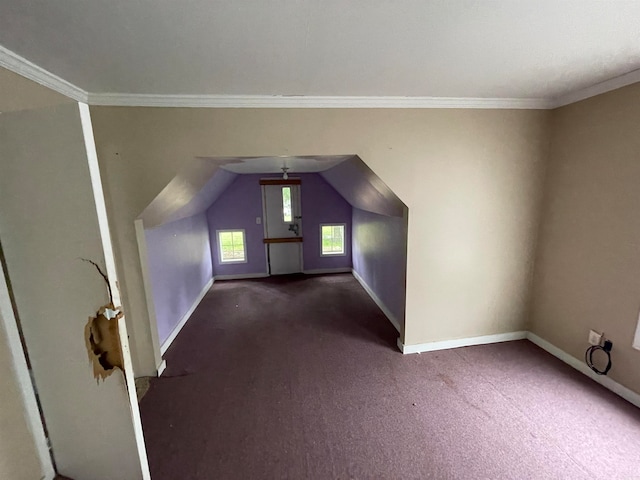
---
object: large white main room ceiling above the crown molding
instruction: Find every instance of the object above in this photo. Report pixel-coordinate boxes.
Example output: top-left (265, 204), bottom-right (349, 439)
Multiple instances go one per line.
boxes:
top-left (0, 0), bottom-right (640, 102)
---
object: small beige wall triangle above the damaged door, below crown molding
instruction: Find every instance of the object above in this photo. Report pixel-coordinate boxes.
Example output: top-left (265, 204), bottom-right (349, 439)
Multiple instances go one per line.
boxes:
top-left (0, 67), bottom-right (74, 113)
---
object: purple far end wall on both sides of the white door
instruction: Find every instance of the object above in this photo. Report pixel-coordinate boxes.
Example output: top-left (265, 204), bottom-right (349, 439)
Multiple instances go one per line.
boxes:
top-left (207, 173), bottom-right (351, 275)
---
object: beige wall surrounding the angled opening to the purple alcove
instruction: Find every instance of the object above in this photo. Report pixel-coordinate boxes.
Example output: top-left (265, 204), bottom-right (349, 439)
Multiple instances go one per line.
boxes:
top-left (91, 107), bottom-right (549, 375)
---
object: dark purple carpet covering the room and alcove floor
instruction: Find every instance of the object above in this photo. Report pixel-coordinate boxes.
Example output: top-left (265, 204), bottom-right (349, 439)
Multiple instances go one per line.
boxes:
top-left (141, 274), bottom-right (640, 480)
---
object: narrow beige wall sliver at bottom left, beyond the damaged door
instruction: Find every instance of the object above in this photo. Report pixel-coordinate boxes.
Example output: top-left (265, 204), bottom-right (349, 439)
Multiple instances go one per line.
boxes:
top-left (0, 310), bottom-right (44, 480)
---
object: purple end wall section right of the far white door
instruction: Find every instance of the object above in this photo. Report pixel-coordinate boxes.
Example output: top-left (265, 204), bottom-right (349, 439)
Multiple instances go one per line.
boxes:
top-left (296, 173), bottom-right (352, 271)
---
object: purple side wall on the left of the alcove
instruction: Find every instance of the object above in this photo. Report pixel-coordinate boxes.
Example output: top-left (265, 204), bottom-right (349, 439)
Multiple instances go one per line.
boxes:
top-left (145, 213), bottom-right (212, 344)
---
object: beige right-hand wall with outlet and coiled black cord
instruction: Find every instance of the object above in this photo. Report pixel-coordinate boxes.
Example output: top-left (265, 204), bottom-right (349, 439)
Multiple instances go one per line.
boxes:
top-left (531, 84), bottom-right (640, 393)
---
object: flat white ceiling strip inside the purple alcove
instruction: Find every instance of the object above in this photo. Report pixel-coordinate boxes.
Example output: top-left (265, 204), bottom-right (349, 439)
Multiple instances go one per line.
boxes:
top-left (215, 155), bottom-right (353, 174)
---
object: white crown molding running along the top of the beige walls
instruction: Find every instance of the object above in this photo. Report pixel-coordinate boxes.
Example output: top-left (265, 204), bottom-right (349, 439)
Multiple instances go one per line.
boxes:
top-left (0, 45), bottom-right (640, 110)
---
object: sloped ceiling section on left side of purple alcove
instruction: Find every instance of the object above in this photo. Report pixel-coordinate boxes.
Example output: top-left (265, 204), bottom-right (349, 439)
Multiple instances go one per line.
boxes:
top-left (138, 158), bottom-right (238, 228)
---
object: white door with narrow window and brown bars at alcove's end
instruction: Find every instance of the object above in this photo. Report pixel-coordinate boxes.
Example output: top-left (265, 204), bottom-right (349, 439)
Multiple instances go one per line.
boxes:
top-left (261, 179), bottom-right (302, 275)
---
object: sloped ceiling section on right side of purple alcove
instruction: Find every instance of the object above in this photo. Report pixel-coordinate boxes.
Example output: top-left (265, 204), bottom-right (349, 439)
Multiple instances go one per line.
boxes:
top-left (320, 155), bottom-right (407, 217)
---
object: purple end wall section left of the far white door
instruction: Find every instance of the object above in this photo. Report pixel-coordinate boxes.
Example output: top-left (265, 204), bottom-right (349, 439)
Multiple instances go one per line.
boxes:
top-left (207, 175), bottom-right (267, 276)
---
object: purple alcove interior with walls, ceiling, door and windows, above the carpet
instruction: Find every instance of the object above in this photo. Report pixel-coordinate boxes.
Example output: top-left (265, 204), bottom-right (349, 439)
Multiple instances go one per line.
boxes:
top-left (136, 155), bottom-right (408, 372)
